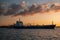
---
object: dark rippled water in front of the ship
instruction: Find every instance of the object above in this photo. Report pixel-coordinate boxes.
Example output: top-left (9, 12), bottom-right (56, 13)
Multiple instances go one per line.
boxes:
top-left (0, 28), bottom-right (60, 40)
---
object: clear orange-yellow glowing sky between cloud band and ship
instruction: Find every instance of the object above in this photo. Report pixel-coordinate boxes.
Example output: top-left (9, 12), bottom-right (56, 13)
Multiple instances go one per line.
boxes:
top-left (0, 12), bottom-right (60, 26)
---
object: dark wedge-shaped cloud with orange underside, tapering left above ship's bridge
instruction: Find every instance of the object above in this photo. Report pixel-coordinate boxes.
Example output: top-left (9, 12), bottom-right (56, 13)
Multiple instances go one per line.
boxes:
top-left (14, 5), bottom-right (41, 16)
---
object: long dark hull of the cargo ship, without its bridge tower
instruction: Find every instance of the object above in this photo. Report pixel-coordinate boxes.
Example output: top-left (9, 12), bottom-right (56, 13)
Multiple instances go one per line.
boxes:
top-left (13, 25), bottom-right (55, 29)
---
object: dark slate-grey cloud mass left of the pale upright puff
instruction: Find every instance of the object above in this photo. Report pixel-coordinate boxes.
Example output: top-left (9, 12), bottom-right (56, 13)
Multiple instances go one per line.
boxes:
top-left (4, 4), bottom-right (21, 15)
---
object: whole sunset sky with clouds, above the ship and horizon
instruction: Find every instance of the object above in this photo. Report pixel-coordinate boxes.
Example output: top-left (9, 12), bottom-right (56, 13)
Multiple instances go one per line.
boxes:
top-left (0, 0), bottom-right (60, 26)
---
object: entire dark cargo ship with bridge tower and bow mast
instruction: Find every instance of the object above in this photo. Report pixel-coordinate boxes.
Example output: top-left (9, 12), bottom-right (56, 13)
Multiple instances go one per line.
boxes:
top-left (11, 19), bottom-right (56, 29)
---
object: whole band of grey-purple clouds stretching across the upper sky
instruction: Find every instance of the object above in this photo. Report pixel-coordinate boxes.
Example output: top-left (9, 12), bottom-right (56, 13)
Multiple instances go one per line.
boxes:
top-left (0, 1), bottom-right (60, 16)
